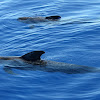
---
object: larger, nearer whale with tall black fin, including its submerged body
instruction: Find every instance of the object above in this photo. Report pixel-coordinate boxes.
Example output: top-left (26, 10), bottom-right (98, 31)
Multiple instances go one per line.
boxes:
top-left (0, 51), bottom-right (100, 74)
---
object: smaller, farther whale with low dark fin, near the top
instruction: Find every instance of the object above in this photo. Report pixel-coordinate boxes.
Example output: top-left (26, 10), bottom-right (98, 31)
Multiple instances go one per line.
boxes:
top-left (18, 16), bottom-right (61, 23)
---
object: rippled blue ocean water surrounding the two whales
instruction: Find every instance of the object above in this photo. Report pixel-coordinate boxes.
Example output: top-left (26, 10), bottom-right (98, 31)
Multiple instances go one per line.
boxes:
top-left (0, 0), bottom-right (100, 100)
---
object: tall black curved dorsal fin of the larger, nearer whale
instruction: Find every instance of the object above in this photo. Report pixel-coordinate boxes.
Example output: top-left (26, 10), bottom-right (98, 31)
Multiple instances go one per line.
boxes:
top-left (21, 51), bottom-right (45, 61)
